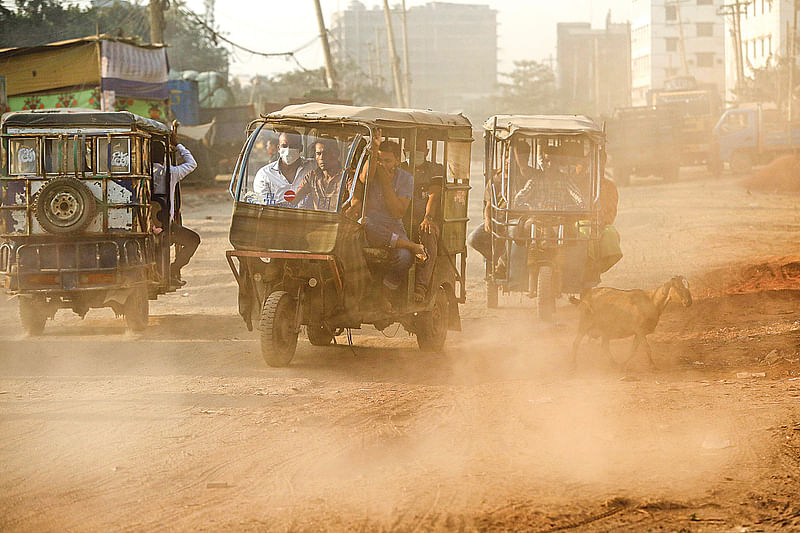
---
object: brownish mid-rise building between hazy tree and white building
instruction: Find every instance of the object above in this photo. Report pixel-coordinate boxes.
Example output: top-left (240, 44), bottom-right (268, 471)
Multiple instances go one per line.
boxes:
top-left (557, 13), bottom-right (631, 116)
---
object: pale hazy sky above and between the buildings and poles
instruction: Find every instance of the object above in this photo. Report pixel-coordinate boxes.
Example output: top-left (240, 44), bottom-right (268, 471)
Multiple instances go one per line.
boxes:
top-left (180, 0), bottom-right (630, 76)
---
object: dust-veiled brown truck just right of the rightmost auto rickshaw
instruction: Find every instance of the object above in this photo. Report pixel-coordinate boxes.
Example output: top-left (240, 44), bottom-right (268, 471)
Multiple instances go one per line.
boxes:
top-left (606, 106), bottom-right (682, 186)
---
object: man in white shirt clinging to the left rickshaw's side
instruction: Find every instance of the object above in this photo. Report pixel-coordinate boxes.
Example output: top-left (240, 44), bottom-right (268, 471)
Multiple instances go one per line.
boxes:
top-left (152, 133), bottom-right (200, 287)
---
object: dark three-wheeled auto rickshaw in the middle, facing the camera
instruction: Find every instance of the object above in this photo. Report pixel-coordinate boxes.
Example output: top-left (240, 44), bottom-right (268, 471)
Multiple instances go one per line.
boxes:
top-left (227, 103), bottom-right (472, 366)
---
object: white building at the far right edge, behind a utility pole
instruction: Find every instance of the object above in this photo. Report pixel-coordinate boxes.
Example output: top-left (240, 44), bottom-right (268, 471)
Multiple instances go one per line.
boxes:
top-left (725, 0), bottom-right (800, 100)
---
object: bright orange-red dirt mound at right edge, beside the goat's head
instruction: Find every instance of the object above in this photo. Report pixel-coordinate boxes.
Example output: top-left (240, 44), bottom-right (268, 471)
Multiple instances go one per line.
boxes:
top-left (692, 256), bottom-right (800, 298)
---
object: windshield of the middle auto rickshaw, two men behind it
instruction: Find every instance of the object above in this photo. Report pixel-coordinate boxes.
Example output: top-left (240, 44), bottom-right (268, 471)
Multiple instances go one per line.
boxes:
top-left (237, 124), bottom-right (367, 212)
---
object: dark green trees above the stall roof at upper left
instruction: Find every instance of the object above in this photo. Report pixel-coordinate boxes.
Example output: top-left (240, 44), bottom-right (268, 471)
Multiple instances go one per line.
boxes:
top-left (0, 0), bottom-right (228, 73)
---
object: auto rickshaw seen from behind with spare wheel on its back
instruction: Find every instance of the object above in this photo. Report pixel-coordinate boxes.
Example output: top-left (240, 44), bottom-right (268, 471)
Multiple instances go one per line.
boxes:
top-left (0, 110), bottom-right (181, 335)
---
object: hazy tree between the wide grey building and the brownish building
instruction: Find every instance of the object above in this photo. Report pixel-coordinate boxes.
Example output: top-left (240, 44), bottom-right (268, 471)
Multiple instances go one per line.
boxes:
top-left (495, 61), bottom-right (559, 115)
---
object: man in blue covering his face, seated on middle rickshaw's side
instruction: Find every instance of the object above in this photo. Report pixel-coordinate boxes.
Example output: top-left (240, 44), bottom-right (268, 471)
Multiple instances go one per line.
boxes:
top-left (351, 141), bottom-right (427, 312)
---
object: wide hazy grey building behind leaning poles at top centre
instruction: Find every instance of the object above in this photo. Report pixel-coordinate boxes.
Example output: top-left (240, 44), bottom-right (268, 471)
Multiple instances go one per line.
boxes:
top-left (331, 0), bottom-right (497, 112)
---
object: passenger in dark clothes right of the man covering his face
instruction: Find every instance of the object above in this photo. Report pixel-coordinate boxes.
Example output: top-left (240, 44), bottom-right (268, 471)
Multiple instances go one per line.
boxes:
top-left (406, 139), bottom-right (444, 302)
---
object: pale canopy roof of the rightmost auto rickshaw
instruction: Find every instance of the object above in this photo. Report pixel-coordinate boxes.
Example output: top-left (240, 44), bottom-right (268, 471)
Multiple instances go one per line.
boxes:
top-left (483, 115), bottom-right (605, 142)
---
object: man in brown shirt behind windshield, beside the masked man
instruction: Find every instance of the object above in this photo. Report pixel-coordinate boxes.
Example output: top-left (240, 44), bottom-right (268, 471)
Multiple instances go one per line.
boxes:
top-left (291, 140), bottom-right (343, 211)
